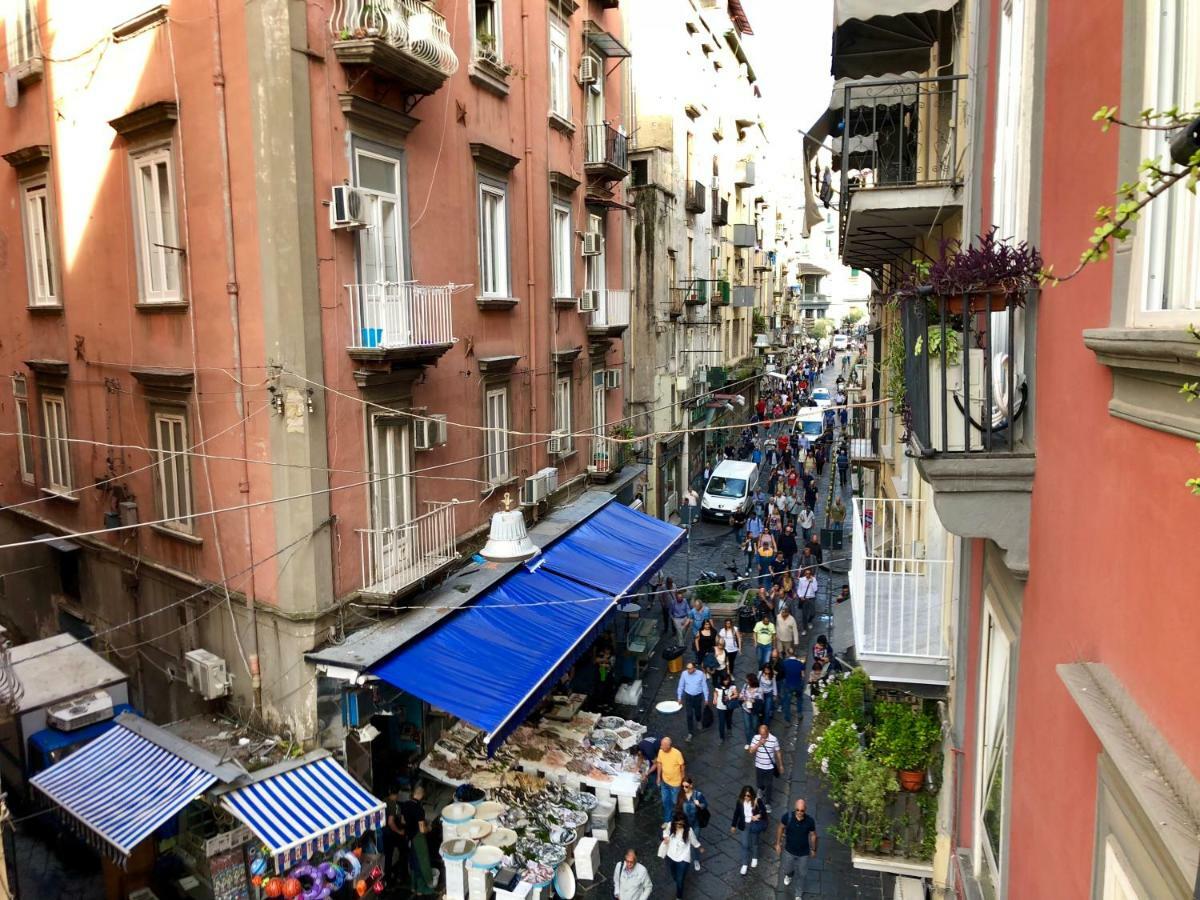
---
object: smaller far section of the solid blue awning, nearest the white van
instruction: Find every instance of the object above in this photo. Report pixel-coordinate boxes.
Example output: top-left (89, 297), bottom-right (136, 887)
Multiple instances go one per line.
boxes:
top-left (536, 503), bottom-right (684, 598)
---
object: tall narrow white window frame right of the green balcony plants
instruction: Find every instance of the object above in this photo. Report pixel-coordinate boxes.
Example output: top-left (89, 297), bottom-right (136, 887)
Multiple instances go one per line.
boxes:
top-left (974, 595), bottom-right (1015, 896)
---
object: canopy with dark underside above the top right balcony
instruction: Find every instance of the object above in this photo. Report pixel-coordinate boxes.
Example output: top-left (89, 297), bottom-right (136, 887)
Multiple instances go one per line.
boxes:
top-left (832, 0), bottom-right (956, 78)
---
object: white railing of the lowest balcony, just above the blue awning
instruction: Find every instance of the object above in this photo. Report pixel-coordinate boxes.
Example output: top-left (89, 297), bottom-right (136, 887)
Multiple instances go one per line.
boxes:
top-left (356, 503), bottom-right (458, 594)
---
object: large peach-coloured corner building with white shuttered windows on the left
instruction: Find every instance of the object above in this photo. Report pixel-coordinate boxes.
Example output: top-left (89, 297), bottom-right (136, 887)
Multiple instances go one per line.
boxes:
top-left (0, 0), bottom-right (632, 738)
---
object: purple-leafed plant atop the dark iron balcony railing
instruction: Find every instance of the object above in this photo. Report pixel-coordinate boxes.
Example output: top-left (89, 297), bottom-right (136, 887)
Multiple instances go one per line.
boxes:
top-left (928, 228), bottom-right (1042, 302)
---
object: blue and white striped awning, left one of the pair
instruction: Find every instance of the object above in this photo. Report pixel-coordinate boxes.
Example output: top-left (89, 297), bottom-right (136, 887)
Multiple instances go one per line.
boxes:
top-left (30, 722), bottom-right (217, 864)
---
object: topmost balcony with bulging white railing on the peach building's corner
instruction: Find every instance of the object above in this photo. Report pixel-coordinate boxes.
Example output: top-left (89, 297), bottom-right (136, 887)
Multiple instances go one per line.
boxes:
top-left (329, 0), bottom-right (458, 95)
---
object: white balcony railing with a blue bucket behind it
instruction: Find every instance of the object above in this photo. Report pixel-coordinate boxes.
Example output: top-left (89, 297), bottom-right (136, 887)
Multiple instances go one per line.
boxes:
top-left (346, 282), bottom-right (461, 350)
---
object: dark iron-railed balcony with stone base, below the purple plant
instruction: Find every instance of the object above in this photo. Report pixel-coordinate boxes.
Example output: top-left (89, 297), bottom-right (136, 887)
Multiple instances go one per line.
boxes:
top-left (901, 292), bottom-right (1037, 576)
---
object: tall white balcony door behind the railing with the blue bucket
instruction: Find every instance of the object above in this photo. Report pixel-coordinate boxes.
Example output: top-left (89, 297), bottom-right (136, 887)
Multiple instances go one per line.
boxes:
top-left (354, 149), bottom-right (413, 347)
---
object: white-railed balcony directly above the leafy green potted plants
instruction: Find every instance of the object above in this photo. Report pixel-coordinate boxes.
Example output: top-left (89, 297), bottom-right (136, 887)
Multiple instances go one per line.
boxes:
top-left (850, 497), bottom-right (950, 685)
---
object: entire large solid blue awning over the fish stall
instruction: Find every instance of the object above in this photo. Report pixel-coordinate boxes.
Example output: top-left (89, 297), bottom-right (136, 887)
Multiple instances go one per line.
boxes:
top-left (371, 503), bottom-right (684, 751)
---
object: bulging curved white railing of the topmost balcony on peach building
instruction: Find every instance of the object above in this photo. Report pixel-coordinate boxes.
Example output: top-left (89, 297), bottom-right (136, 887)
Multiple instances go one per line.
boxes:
top-left (329, 0), bottom-right (458, 76)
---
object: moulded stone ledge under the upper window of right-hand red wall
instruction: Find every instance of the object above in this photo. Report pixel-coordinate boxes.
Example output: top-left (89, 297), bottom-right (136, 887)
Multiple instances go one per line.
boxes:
top-left (1084, 328), bottom-right (1200, 440)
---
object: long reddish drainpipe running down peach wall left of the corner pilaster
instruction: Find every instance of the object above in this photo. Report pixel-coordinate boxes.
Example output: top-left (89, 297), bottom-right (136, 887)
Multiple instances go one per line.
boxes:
top-left (209, 0), bottom-right (263, 714)
